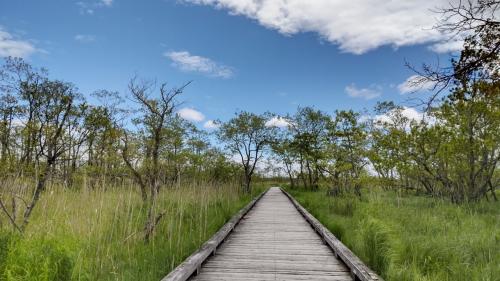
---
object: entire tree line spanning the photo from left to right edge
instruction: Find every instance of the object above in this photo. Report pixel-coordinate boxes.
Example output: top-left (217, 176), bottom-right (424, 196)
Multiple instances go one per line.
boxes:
top-left (0, 0), bottom-right (500, 241)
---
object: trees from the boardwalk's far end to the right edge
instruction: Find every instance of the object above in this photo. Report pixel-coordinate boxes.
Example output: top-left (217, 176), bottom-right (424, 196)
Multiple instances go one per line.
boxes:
top-left (217, 0), bottom-right (500, 203)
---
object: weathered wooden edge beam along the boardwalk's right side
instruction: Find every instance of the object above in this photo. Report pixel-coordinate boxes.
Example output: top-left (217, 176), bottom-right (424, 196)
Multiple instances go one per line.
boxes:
top-left (280, 188), bottom-right (384, 281)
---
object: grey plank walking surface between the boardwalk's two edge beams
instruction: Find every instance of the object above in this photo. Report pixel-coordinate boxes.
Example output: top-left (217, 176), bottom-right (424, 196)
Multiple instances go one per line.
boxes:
top-left (190, 187), bottom-right (353, 281)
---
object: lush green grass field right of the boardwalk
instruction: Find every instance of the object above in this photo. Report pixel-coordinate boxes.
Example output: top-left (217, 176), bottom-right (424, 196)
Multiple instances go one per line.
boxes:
top-left (289, 186), bottom-right (500, 281)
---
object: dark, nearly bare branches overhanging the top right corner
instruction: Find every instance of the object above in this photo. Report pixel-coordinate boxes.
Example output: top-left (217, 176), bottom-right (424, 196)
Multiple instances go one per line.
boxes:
top-left (406, 0), bottom-right (500, 104)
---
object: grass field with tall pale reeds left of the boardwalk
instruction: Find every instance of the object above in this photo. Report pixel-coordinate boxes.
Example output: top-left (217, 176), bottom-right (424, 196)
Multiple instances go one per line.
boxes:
top-left (0, 180), bottom-right (262, 280)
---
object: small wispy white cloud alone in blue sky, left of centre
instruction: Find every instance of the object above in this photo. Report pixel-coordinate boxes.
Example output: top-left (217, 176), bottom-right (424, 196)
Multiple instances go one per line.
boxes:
top-left (163, 51), bottom-right (234, 78)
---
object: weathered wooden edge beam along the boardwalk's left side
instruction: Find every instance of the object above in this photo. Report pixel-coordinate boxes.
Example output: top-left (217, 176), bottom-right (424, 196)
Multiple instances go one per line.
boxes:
top-left (161, 189), bottom-right (269, 281)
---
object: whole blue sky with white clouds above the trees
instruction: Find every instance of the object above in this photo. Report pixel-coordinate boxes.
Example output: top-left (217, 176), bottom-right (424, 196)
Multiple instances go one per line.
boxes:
top-left (0, 0), bottom-right (459, 126)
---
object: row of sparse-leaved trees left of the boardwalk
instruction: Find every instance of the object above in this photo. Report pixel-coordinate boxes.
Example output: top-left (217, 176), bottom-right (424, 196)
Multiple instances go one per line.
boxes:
top-left (0, 58), bottom-right (239, 236)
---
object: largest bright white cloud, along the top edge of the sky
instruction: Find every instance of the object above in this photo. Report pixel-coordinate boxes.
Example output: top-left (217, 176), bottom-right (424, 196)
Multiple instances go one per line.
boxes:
top-left (182, 0), bottom-right (457, 54)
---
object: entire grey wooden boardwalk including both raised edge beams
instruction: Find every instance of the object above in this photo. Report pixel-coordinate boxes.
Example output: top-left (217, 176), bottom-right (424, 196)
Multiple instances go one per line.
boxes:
top-left (162, 187), bottom-right (382, 281)
